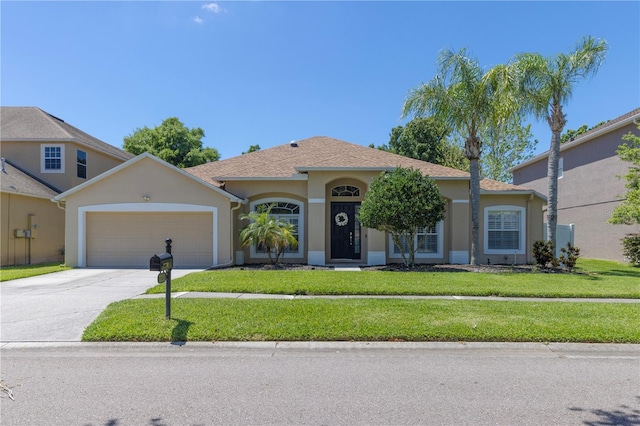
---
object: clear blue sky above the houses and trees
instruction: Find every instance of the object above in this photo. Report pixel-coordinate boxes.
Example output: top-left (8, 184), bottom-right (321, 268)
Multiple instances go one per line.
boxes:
top-left (0, 0), bottom-right (640, 158)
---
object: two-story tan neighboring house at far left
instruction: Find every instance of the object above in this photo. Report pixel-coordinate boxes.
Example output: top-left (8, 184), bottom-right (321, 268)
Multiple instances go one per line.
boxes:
top-left (0, 107), bottom-right (133, 266)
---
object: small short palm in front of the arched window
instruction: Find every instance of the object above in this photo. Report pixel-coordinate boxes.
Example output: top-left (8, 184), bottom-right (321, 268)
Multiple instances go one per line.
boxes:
top-left (240, 205), bottom-right (298, 263)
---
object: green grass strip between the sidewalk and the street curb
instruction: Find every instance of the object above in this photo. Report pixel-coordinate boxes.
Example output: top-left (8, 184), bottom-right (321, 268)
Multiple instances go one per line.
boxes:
top-left (83, 299), bottom-right (640, 343)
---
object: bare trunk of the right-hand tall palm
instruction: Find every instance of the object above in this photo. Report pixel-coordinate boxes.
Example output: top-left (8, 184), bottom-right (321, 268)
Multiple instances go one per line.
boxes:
top-left (547, 105), bottom-right (567, 250)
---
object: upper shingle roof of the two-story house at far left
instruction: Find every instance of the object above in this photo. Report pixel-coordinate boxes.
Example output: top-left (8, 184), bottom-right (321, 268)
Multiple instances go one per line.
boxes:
top-left (0, 106), bottom-right (134, 160)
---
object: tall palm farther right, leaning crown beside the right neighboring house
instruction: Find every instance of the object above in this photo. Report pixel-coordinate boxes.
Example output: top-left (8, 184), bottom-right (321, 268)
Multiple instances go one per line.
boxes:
top-left (512, 36), bottom-right (608, 250)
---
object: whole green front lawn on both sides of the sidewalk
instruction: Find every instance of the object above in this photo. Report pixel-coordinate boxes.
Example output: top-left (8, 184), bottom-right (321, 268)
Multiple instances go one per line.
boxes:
top-left (83, 261), bottom-right (640, 343)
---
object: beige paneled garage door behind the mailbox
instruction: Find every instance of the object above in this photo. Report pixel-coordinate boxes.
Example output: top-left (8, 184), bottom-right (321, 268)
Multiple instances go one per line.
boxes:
top-left (86, 212), bottom-right (213, 268)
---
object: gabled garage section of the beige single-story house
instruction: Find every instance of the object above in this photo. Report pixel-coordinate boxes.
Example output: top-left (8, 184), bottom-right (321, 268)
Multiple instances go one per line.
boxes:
top-left (53, 153), bottom-right (246, 269)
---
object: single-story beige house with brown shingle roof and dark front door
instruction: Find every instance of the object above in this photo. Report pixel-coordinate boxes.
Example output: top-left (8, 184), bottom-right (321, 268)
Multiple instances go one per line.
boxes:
top-left (54, 137), bottom-right (546, 268)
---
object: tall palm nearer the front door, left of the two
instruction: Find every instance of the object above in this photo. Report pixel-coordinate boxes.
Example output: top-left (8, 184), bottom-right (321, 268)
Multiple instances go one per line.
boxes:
top-left (402, 48), bottom-right (511, 265)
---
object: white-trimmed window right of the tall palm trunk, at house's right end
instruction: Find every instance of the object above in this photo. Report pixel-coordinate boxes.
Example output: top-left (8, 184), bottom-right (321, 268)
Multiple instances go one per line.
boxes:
top-left (484, 206), bottom-right (526, 254)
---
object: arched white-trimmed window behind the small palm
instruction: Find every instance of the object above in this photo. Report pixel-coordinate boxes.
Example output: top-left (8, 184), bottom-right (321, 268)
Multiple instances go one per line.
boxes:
top-left (250, 198), bottom-right (304, 258)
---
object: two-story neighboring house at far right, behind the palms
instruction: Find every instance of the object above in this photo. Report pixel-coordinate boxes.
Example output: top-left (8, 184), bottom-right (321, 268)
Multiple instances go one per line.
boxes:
top-left (511, 108), bottom-right (640, 261)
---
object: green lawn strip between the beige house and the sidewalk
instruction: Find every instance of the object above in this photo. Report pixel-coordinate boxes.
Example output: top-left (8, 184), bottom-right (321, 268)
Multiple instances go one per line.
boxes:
top-left (147, 259), bottom-right (640, 298)
